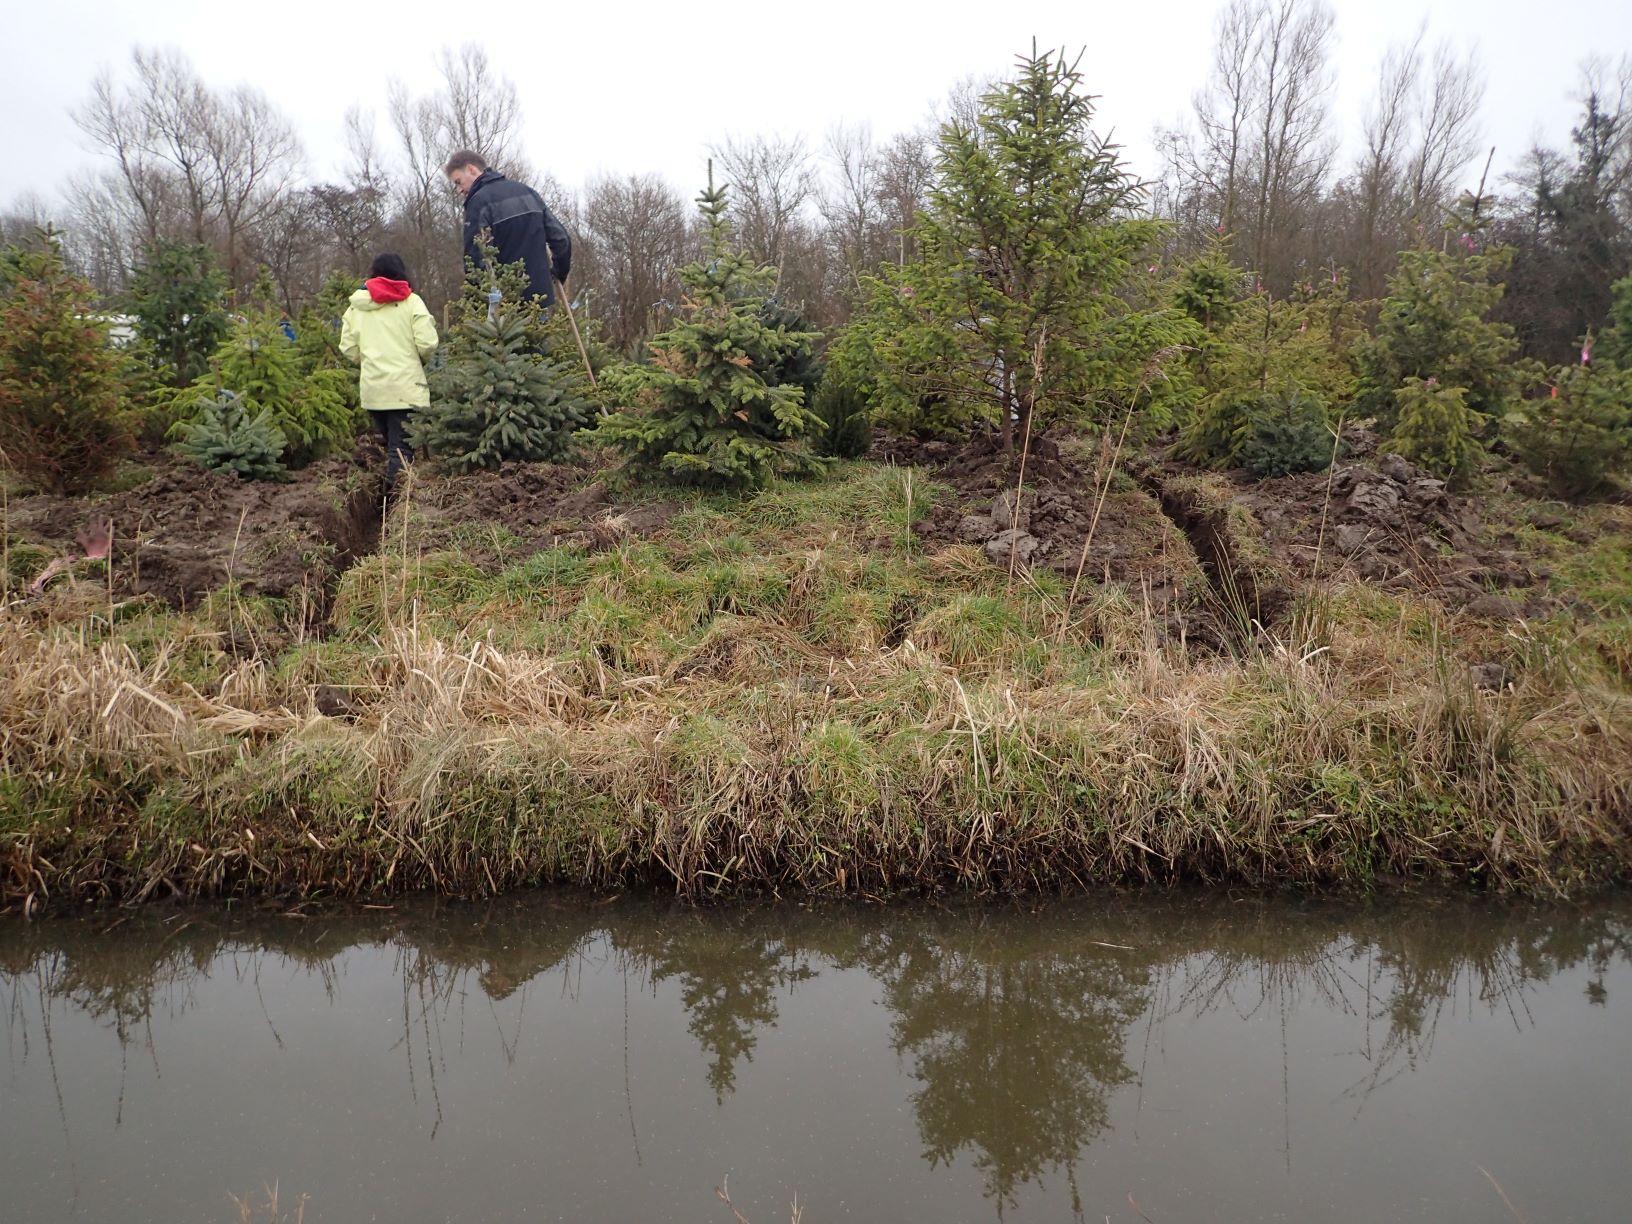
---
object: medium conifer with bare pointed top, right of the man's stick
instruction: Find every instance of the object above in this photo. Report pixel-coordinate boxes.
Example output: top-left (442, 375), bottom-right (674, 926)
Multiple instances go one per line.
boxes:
top-left (594, 163), bottom-right (826, 490)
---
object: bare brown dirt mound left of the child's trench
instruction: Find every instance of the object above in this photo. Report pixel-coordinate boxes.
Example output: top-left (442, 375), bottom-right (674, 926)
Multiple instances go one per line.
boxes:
top-left (7, 455), bottom-right (379, 607)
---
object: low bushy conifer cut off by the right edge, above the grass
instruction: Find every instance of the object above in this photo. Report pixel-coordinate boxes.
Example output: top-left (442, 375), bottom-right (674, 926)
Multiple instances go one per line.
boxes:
top-left (1510, 362), bottom-right (1632, 498)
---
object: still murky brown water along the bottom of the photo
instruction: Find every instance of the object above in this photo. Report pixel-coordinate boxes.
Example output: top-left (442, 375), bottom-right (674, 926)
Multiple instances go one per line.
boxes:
top-left (0, 898), bottom-right (1632, 1224)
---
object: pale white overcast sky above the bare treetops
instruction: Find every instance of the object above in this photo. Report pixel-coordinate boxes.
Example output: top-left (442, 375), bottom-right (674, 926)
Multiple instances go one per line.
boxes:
top-left (0, 0), bottom-right (1632, 215)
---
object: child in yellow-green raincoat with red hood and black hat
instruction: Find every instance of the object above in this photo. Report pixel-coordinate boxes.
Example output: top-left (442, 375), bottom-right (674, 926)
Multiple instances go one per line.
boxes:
top-left (339, 253), bottom-right (436, 493)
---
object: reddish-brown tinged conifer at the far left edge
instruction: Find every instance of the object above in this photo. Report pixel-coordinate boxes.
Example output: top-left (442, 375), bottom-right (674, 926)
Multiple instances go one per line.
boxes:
top-left (0, 230), bottom-right (132, 493)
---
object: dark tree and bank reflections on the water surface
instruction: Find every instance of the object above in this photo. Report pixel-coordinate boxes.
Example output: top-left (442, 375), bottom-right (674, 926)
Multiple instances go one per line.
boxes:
top-left (0, 898), bottom-right (1632, 1217)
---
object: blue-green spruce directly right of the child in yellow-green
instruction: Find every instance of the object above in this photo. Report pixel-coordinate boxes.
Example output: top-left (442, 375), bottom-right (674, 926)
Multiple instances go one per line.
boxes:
top-left (411, 259), bottom-right (592, 472)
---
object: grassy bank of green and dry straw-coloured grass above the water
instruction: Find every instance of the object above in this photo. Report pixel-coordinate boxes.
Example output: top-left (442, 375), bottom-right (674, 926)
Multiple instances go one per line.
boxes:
top-left (0, 463), bottom-right (1632, 909)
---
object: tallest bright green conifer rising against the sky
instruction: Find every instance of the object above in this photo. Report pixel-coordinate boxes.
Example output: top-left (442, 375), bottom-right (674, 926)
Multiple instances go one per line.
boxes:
top-left (850, 51), bottom-right (1200, 446)
